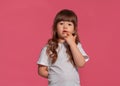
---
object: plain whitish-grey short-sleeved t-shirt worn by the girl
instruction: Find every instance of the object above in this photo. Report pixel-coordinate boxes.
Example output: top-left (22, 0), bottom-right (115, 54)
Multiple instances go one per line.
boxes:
top-left (37, 42), bottom-right (89, 86)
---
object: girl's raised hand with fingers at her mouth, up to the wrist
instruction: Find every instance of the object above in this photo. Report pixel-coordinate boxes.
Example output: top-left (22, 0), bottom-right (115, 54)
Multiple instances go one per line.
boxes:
top-left (64, 32), bottom-right (76, 45)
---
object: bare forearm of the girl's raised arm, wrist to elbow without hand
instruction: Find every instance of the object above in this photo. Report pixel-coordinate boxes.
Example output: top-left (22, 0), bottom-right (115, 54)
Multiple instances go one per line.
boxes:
top-left (70, 43), bottom-right (85, 67)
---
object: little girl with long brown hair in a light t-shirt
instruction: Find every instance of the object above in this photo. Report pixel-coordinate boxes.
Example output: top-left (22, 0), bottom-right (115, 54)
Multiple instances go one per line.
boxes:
top-left (37, 9), bottom-right (89, 86)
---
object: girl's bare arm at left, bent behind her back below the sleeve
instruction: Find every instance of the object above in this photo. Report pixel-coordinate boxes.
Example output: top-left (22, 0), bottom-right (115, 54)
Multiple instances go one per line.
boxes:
top-left (38, 65), bottom-right (48, 78)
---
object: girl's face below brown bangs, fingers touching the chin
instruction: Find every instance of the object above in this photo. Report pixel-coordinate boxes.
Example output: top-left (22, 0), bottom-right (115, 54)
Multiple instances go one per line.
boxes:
top-left (57, 21), bottom-right (74, 39)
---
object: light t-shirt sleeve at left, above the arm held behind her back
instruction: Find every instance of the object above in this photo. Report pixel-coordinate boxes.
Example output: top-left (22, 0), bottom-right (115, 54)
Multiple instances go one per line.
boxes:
top-left (37, 46), bottom-right (49, 66)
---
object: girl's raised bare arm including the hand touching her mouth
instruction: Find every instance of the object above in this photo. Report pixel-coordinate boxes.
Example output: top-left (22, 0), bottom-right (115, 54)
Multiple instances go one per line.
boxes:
top-left (64, 32), bottom-right (86, 67)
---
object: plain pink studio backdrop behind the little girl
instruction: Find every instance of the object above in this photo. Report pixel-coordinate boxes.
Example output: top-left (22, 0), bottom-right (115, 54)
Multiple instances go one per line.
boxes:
top-left (0, 0), bottom-right (120, 86)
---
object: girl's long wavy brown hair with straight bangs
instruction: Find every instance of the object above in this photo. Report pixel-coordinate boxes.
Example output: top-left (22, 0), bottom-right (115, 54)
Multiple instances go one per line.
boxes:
top-left (46, 9), bottom-right (80, 64)
